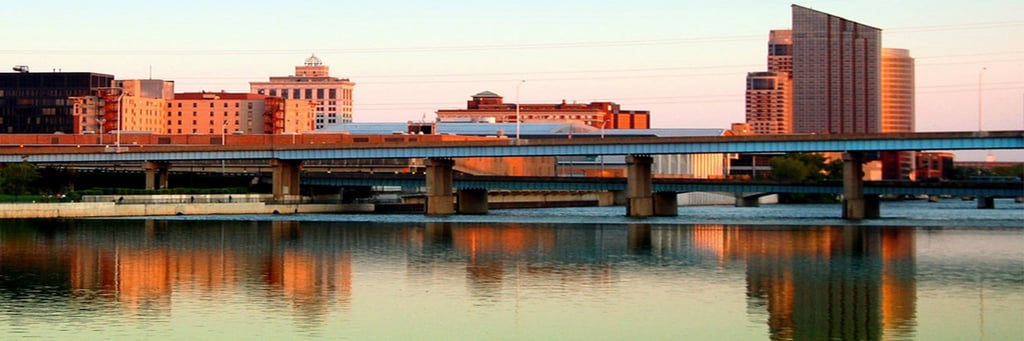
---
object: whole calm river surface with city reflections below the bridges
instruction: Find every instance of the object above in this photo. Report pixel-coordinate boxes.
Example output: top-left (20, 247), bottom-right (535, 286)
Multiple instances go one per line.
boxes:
top-left (0, 200), bottom-right (1024, 340)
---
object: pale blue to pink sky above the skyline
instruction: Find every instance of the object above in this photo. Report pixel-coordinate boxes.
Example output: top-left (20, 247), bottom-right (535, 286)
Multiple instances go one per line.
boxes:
top-left (6, 0), bottom-right (1024, 161)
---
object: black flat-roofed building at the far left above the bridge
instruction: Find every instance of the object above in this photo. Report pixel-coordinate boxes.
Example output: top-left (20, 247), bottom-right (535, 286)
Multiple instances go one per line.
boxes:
top-left (0, 73), bottom-right (114, 134)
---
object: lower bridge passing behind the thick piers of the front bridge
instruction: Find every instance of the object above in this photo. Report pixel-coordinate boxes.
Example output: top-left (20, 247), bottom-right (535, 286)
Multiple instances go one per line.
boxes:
top-left (302, 173), bottom-right (1024, 216)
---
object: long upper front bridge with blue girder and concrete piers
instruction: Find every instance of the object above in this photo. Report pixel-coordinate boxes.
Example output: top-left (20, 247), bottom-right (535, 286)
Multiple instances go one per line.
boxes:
top-left (0, 130), bottom-right (1024, 219)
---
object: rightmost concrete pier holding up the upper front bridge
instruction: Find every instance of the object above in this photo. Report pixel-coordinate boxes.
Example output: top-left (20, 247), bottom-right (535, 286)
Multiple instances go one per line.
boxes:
top-left (843, 152), bottom-right (881, 220)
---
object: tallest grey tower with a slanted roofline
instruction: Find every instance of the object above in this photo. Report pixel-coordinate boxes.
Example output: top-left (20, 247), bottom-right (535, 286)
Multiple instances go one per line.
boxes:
top-left (793, 5), bottom-right (882, 134)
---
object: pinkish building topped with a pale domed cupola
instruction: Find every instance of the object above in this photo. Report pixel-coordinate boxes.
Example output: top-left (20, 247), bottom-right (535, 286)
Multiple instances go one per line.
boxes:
top-left (249, 55), bottom-right (355, 129)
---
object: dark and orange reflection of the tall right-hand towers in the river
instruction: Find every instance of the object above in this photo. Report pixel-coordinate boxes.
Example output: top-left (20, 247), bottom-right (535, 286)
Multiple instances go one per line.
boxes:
top-left (693, 225), bottom-right (916, 340)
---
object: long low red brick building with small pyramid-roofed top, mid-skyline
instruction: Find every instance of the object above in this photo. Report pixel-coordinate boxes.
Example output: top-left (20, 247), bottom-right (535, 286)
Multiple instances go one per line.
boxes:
top-left (437, 91), bottom-right (650, 129)
